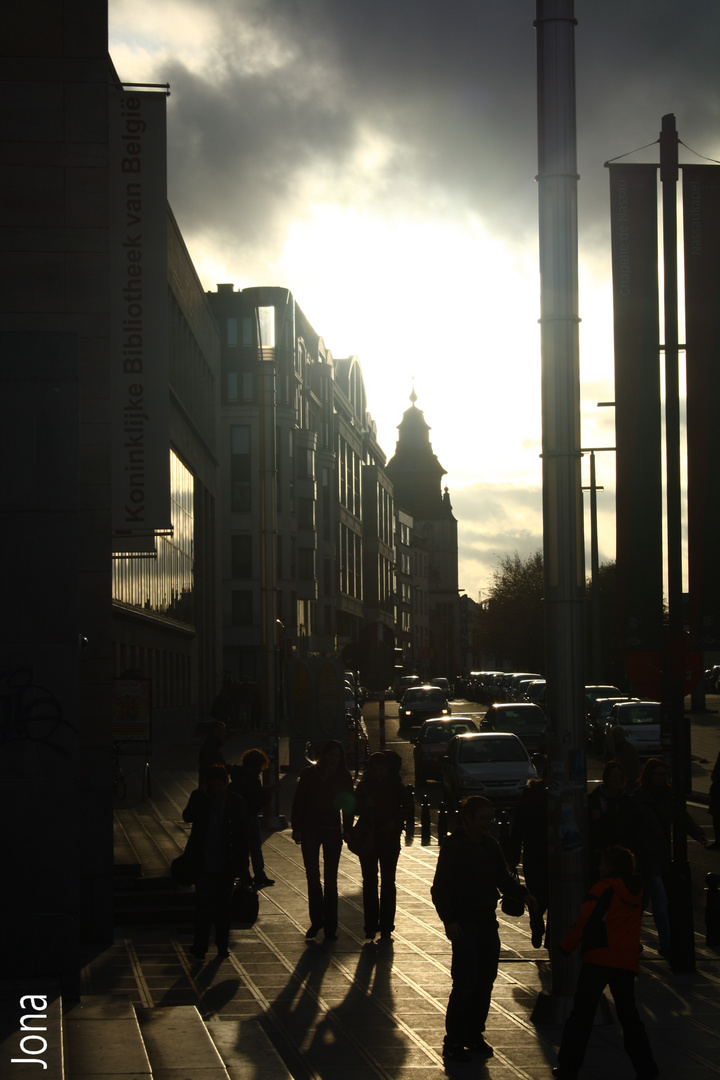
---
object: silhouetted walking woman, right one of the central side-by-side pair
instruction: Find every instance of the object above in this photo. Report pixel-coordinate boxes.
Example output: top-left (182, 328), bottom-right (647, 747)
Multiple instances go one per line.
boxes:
top-left (355, 751), bottom-right (415, 942)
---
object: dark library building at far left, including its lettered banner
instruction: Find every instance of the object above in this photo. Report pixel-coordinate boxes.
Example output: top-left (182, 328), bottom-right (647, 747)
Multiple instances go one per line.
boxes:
top-left (0, 0), bottom-right (218, 997)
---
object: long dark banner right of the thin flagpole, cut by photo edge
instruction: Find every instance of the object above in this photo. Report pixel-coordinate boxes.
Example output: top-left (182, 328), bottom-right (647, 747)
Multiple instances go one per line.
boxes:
top-left (682, 165), bottom-right (720, 650)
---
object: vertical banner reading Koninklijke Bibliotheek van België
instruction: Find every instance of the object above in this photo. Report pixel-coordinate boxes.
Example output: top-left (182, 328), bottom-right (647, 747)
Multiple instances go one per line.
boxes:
top-left (109, 87), bottom-right (171, 552)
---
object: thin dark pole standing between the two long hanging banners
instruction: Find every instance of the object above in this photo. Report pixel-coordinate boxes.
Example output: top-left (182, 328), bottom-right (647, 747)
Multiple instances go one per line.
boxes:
top-left (660, 113), bottom-right (695, 971)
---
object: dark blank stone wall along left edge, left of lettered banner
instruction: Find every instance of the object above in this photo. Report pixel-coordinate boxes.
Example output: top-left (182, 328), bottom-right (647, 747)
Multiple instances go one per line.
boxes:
top-left (0, 0), bottom-right (112, 994)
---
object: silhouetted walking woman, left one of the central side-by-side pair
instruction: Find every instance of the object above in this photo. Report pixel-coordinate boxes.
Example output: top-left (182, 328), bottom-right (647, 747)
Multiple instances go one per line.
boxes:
top-left (290, 739), bottom-right (355, 941)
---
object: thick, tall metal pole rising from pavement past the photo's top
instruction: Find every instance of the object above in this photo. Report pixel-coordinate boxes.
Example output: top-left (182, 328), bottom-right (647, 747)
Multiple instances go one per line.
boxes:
top-left (533, 0), bottom-right (587, 1023)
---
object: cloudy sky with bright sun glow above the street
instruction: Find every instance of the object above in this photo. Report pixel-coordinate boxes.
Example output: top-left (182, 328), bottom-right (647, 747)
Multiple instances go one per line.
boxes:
top-left (110, 0), bottom-right (720, 596)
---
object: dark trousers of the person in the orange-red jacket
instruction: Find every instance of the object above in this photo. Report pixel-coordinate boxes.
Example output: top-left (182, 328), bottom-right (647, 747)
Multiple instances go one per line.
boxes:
top-left (557, 963), bottom-right (658, 1080)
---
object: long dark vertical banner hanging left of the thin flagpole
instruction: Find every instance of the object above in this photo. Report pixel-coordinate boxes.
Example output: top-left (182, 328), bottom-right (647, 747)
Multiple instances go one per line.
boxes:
top-left (609, 165), bottom-right (663, 653)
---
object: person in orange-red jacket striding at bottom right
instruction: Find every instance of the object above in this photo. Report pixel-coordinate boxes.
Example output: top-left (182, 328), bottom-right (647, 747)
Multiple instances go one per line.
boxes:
top-left (553, 847), bottom-right (660, 1080)
